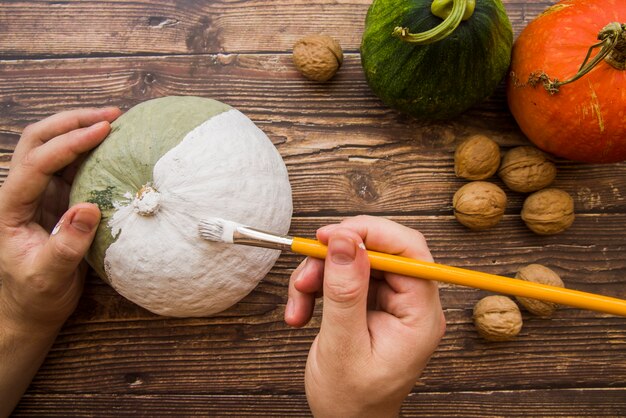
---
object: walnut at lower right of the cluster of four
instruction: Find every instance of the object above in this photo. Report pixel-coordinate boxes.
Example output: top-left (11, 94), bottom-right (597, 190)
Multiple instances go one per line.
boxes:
top-left (522, 188), bottom-right (574, 235)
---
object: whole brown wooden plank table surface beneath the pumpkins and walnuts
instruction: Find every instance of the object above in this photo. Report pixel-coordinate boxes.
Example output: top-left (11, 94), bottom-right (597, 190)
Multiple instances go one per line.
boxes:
top-left (0, 0), bottom-right (626, 417)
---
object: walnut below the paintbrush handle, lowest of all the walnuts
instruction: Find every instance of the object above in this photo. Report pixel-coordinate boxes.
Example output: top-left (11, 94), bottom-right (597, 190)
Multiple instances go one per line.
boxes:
top-left (474, 295), bottom-right (522, 341)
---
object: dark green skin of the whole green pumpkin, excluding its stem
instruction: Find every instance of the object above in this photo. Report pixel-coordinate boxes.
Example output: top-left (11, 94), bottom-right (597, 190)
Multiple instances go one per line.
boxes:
top-left (361, 0), bottom-right (513, 120)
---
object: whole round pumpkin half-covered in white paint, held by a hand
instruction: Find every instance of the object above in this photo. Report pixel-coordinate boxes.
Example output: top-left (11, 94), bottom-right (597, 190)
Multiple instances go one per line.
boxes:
top-left (70, 97), bottom-right (292, 317)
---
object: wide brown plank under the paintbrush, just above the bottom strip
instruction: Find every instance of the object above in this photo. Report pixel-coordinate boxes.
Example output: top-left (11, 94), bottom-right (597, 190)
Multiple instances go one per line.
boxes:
top-left (17, 215), bottom-right (626, 394)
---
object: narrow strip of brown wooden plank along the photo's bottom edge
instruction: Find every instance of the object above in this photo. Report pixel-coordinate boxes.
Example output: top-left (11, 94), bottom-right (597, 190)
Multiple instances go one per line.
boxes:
top-left (13, 388), bottom-right (626, 418)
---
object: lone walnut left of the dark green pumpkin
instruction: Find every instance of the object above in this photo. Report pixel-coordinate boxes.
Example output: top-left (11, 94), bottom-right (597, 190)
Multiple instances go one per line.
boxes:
top-left (293, 35), bottom-right (343, 81)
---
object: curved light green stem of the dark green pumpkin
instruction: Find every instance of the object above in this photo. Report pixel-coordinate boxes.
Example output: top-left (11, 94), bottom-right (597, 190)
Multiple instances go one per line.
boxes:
top-left (393, 0), bottom-right (468, 45)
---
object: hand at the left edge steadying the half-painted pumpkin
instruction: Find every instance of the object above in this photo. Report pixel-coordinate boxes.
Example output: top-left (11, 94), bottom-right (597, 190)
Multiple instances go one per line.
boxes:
top-left (0, 108), bottom-right (120, 416)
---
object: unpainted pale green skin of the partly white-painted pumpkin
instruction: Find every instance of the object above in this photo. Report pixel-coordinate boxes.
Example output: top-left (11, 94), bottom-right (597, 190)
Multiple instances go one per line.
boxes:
top-left (70, 96), bottom-right (231, 282)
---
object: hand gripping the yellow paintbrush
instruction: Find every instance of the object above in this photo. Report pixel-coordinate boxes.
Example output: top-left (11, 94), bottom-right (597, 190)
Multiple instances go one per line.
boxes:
top-left (285, 216), bottom-right (445, 417)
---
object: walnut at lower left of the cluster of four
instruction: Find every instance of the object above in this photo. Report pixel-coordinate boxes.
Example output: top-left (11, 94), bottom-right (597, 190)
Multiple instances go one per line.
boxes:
top-left (452, 181), bottom-right (506, 231)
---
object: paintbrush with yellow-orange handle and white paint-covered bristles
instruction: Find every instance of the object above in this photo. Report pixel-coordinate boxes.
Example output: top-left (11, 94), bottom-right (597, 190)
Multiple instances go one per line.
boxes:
top-left (198, 218), bottom-right (626, 316)
